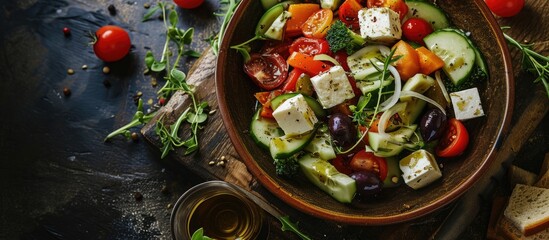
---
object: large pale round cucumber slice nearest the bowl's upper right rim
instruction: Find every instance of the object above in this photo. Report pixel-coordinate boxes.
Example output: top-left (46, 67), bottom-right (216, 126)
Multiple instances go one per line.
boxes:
top-left (423, 29), bottom-right (476, 86)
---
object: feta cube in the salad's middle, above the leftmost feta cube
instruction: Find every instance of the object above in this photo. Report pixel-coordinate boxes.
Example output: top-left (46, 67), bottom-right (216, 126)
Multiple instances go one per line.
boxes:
top-left (311, 66), bottom-right (355, 108)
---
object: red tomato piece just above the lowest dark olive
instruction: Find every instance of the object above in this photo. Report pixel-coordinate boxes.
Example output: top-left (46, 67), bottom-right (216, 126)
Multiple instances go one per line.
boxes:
top-left (349, 150), bottom-right (387, 181)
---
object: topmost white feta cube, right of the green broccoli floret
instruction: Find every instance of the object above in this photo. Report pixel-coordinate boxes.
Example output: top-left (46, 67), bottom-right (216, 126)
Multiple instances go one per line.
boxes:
top-left (358, 7), bottom-right (402, 44)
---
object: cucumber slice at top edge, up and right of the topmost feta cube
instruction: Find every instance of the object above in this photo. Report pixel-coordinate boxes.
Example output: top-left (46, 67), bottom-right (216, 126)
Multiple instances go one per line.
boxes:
top-left (406, 1), bottom-right (450, 30)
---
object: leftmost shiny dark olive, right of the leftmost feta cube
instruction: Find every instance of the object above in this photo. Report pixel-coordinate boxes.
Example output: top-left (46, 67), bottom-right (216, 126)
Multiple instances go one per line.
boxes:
top-left (328, 113), bottom-right (357, 148)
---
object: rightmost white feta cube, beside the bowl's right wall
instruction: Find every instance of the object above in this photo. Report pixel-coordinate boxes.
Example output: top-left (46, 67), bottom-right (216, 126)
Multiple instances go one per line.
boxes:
top-left (450, 88), bottom-right (484, 120)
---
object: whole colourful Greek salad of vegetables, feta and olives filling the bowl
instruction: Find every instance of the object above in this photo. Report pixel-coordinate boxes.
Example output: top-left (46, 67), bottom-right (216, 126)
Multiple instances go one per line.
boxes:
top-left (232, 0), bottom-right (488, 203)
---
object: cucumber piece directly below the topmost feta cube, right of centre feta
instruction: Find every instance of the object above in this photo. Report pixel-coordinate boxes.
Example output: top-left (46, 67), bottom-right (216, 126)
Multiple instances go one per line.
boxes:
top-left (347, 45), bottom-right (391, 81)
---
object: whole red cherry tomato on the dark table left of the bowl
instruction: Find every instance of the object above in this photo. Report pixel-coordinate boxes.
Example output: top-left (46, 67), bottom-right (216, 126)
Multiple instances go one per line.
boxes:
top-left (93, 25), bottom-right (131, 62)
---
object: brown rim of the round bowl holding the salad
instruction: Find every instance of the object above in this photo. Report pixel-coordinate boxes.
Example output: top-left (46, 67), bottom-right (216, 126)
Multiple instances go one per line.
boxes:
top-left (215, 0), bottom-right (514, 225)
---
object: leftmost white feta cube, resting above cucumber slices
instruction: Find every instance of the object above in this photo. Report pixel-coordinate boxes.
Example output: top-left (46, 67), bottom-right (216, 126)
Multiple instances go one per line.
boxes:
top-left (273, 94), bottom-right (318, 136)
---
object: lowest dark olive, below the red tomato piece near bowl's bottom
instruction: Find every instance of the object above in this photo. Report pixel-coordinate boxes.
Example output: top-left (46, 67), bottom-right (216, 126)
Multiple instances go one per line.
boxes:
top-left (350, 171), bottom-right (383, 200)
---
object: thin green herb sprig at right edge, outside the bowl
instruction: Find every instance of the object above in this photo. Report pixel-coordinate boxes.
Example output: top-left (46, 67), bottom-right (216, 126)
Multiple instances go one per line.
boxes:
top-left (501, 27), bottom-right (549, 97)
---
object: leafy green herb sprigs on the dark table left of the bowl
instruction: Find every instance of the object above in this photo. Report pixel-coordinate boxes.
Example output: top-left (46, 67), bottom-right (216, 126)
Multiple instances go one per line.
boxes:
top-left (105, 2), bottom-right (209, 158)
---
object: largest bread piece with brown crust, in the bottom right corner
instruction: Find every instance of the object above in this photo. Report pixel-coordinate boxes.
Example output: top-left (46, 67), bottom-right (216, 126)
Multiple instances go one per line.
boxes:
top-left (504, 184), bottom-right (549, 236)
